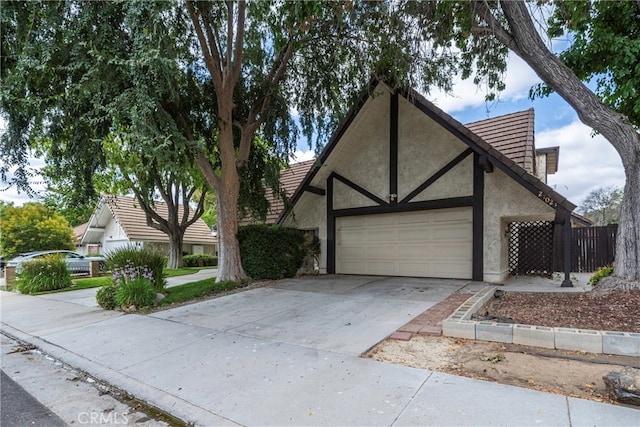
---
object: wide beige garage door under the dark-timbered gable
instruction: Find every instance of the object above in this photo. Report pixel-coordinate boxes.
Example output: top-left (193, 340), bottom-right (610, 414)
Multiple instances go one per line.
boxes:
top-left (336, 208), bottom-right (473, 279)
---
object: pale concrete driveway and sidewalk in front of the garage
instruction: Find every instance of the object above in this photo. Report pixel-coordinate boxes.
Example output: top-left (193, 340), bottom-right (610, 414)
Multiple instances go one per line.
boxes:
top-left (0, 276), bottom-right (640, 427)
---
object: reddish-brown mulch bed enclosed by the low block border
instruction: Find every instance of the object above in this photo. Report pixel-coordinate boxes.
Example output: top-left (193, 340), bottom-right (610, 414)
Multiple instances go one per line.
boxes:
top-left (478, 290), bottom-right (640, 333)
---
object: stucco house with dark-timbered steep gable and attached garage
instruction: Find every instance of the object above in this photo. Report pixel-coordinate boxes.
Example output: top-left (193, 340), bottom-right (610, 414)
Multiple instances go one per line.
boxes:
top-left (249, 81), bottom-right (581, 286)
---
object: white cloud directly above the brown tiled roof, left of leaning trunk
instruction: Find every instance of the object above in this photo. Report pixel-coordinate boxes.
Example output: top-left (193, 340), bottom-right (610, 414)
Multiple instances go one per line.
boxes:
top-left (428, 53), bottom-right (541, 114)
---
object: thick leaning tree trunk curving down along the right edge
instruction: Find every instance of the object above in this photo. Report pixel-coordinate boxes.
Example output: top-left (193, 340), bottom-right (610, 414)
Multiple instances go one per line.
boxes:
top-left (476, 1), bottom-right (640, 281)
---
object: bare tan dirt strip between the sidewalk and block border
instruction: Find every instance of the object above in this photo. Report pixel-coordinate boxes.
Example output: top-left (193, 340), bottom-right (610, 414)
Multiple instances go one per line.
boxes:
top-left (364, 335), bottom-right (640, 403)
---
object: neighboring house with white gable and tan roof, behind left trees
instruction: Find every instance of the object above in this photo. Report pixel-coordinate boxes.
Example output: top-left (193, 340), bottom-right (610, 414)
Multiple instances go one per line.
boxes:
top-left (74, 196), bottom-right (218, 255)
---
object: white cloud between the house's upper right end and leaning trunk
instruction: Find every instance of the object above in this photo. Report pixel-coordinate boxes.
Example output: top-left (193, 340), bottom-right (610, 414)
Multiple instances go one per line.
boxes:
top-left (536, 119), bottom-right (625, 205)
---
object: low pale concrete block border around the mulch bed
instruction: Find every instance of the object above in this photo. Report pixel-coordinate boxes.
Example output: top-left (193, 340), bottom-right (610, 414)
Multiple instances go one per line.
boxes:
top-left (442, 286), bottom-right (640, 357)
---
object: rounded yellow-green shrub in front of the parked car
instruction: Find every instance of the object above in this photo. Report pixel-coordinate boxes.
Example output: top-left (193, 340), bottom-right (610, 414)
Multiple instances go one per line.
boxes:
top-left (16, 255), bottom-right (71, 294)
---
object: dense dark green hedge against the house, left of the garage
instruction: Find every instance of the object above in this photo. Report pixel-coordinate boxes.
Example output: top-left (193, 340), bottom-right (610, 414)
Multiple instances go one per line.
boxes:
top-left (238, 225), bottom-right (319, 279)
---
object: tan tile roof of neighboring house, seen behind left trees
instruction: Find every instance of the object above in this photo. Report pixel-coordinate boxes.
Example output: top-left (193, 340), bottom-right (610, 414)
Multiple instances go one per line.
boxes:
top-left (103, 196), bottom-right (217, 244)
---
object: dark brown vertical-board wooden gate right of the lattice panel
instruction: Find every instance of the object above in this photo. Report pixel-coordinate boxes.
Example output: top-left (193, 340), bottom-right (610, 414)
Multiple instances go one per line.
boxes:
top-left (553, 224), bottom-right (618, 273)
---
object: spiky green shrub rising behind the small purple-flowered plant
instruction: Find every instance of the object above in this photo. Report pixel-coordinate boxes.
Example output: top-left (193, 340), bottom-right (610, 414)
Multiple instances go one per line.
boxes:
top-left (105, 245), bottom-right (167, 292)
